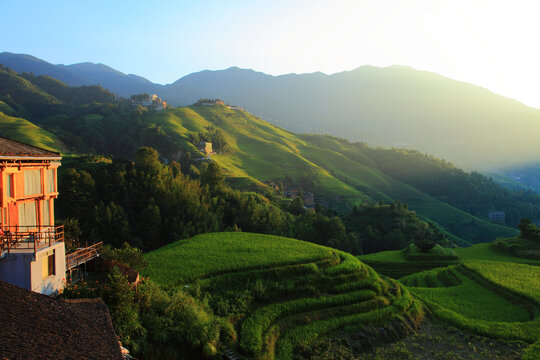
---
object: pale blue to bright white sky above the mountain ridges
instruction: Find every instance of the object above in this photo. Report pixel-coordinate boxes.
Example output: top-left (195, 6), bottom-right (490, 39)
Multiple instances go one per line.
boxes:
top-left (0, 0), bottom-right (540, 108)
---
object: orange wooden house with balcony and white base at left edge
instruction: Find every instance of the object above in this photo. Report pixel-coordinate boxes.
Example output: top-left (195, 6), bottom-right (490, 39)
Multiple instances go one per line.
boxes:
top-left (0, 137), bottom-right (102, 294)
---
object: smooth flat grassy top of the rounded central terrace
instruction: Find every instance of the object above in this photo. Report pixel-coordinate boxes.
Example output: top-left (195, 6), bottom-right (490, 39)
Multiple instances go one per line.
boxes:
top-left (144, 233), bottom-right (332, 285)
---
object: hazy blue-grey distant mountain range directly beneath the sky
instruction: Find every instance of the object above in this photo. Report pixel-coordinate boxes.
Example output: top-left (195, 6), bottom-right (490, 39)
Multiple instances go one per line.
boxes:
top-left (0, 53), bottom-right (540, 170)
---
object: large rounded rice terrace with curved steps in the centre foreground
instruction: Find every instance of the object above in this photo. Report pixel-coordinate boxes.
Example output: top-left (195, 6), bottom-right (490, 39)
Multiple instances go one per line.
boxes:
top-left (144, 233), bottom-right (423, 359)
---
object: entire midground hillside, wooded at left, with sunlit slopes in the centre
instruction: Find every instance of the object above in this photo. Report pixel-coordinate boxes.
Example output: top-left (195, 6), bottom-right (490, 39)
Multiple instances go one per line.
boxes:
top-left (0, 65), bottom-right (540, 251)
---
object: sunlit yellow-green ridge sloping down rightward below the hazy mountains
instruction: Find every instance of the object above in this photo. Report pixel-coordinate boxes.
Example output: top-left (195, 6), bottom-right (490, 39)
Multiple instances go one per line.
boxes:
top-left (143, 105), bottom-right (517, 245)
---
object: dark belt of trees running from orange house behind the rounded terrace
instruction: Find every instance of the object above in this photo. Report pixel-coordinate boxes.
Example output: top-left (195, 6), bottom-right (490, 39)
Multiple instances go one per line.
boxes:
top-left (56, 147), bottom-right (443, 254)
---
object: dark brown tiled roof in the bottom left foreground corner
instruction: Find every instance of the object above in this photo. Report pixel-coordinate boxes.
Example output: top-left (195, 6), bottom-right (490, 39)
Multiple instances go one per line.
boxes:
top-left (0, 281), bottom-right (122, 360)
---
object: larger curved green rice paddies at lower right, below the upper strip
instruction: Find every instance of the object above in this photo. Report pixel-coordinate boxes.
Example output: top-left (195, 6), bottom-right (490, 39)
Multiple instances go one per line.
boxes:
top-left (400, 261), bottom-right (540, 359)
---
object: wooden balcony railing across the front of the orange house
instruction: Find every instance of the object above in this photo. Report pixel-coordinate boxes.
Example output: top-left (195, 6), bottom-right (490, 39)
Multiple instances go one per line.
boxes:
top-left (0, 225), bottom-right (64, 255)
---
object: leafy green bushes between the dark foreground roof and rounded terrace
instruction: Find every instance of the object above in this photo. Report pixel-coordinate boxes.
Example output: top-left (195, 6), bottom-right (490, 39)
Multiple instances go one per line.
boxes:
top-left (62, 262), bottom-right (232, 360)
